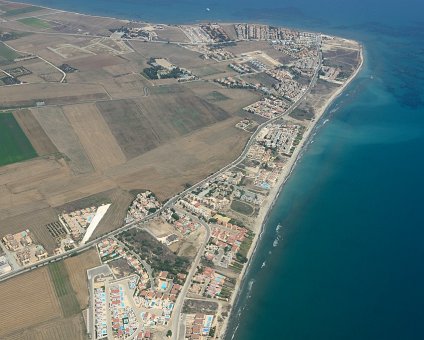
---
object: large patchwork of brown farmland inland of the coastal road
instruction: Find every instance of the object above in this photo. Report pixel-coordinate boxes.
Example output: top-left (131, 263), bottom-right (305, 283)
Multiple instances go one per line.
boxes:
top-left (0, 6), bottom-right (259, 246)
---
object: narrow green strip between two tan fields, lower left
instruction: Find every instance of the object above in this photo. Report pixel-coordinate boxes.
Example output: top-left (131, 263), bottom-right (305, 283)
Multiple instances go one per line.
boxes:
top-left (48, 261), bottom-right (81, 317)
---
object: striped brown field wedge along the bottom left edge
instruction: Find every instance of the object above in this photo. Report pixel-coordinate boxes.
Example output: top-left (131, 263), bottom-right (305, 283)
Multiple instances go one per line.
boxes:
top-left (2, 314), bottom-right (87, 340)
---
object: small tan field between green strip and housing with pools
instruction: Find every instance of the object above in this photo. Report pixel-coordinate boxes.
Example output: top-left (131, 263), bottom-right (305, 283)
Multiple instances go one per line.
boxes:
top-left (64, 248), bottom-right (101, 309)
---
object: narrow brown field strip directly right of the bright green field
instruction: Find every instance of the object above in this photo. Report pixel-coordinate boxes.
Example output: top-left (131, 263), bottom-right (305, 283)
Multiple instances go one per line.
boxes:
top-left (13, 110), bottom-right (58, 156)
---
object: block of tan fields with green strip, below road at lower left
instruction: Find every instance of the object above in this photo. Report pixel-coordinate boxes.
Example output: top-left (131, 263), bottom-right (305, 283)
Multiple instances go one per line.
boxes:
top-left (0, 249), bottom-right (94, 340)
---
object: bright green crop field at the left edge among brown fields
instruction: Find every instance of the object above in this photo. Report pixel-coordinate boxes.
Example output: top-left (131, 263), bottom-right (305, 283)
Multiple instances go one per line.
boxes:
top-left (0, 113), bottom-right (37, 166)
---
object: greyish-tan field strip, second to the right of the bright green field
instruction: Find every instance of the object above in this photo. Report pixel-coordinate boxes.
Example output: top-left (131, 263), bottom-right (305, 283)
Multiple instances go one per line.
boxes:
top-left (32, 107), bottom-right (93, 174)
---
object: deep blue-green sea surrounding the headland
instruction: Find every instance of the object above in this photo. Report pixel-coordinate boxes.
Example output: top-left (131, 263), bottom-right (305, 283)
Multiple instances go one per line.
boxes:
top-left (24, 0), bottom-right (424, 340)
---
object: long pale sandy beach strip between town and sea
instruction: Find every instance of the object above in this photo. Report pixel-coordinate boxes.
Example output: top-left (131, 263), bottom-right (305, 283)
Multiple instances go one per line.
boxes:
top-left (220, 45), bottom-right (364, 339)
